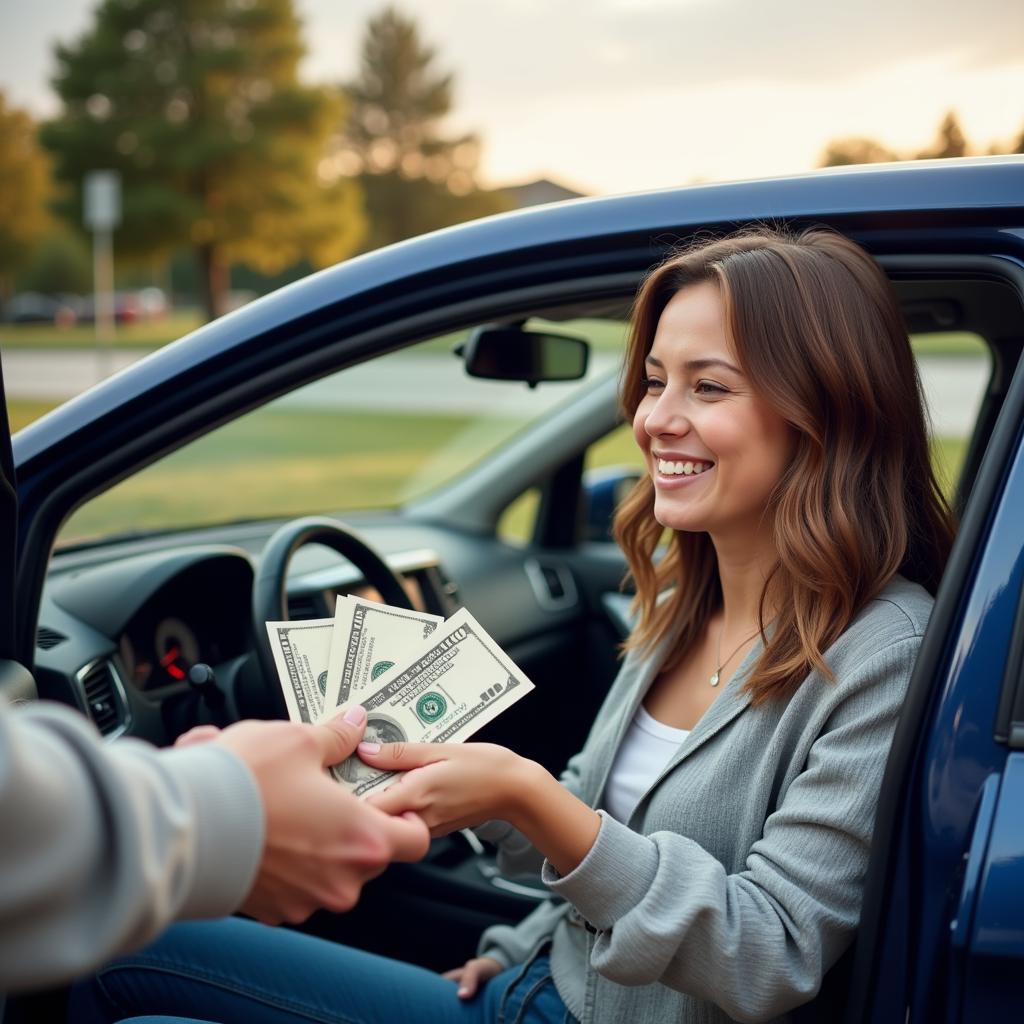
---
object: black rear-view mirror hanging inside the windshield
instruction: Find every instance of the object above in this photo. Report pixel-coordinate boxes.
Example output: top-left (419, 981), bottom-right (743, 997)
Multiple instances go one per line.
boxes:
top-left (455, 325), bottom-right (590, 387)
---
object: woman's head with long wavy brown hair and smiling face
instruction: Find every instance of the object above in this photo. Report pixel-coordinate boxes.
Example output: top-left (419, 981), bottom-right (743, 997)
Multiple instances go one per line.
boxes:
top-left (618, 230), bottom-right (952, 700)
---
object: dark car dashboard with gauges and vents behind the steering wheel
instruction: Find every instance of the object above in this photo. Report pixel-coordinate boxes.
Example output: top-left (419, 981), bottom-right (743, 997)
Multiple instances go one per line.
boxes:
top-left (34, 503), bottom-right (628, 768)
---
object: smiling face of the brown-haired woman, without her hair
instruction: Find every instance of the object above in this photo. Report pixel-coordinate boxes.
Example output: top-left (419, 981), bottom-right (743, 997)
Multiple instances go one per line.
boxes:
top-left (633, 282), bottom-right (795, 540)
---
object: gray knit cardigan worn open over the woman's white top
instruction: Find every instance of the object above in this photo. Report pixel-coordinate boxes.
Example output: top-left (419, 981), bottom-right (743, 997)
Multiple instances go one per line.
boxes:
top-left (479, 577), bottom-right (932, 1024)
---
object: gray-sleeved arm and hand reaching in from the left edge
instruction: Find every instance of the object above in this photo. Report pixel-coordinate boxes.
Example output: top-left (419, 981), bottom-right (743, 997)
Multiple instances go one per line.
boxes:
top-left (0, 700), bottom-right (428, 991)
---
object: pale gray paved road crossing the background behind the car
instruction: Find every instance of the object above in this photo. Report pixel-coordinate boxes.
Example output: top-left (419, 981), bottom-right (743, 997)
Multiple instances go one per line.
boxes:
top-left (2, 349), bottom-right (988, 437)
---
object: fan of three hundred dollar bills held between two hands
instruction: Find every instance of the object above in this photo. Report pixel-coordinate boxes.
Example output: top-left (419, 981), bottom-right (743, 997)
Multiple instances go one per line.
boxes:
top-left (266, 597), bottom-right (534, 797)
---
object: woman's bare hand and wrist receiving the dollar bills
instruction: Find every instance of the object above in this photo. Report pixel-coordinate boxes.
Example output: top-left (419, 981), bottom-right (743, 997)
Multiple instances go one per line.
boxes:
top-left (357, 742), bottom-right (601, 874)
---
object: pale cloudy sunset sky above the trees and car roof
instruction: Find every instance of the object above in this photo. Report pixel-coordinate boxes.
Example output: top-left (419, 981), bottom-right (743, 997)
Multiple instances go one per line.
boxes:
top-left (0, 0), bottom-right (1024, 194)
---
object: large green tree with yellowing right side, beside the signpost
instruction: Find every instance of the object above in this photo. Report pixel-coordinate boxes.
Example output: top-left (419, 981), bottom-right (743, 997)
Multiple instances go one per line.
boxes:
top-left (42, 0), bottom-right (366, 317)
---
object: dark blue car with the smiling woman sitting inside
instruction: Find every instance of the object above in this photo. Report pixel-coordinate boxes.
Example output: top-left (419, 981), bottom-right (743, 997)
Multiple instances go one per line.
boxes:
top-left (0, 158), bottom-right (1024, 1024)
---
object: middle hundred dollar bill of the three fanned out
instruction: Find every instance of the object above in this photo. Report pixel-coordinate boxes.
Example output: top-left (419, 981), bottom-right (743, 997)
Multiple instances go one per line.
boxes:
top-left (324, 597), bottom-right (444, 714)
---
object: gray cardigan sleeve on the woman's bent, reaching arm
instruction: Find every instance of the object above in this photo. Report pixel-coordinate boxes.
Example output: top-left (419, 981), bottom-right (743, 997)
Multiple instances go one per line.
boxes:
top-left (543, 637), bottom-right (921, 1021)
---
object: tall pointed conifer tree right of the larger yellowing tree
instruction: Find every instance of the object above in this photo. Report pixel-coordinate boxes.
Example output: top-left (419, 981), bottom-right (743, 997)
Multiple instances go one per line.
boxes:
top-left (330, 7), bottom-right (511, 249)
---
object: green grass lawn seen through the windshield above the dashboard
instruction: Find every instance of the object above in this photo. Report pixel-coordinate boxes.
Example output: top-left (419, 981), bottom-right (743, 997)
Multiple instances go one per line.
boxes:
top-left (59, 409), bottom-right (519, 544)
